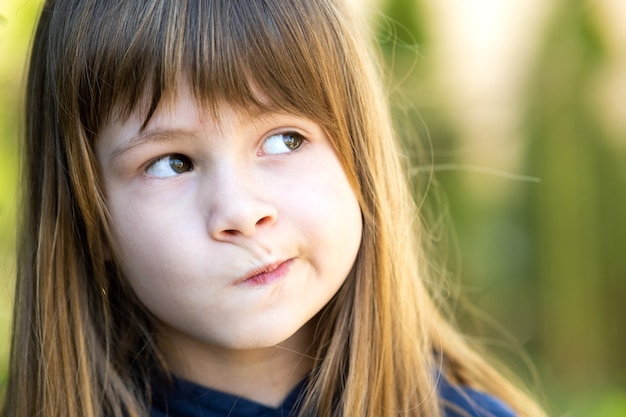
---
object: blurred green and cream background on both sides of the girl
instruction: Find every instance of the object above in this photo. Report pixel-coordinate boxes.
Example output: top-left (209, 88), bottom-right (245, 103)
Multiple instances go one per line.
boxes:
top-left (0, 0), bottom-right (626, 417)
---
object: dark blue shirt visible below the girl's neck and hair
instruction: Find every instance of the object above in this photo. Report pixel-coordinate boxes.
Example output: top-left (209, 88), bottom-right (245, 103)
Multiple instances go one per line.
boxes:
top-left (150, 379), bottom-right (515, 417)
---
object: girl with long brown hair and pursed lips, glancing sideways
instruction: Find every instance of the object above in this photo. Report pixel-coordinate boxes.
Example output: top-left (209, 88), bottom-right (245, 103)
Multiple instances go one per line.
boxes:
top-left (3, 0), bottom-right (543, 417)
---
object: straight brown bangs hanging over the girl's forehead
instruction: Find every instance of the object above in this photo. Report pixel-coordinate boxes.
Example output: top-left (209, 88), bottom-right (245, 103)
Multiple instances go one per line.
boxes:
top-left (58, 0), bottom-right (347, 137)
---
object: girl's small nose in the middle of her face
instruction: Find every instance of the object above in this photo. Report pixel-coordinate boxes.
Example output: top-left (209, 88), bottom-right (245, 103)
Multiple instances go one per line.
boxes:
top-left (207, 166), bottom-right (278, 241)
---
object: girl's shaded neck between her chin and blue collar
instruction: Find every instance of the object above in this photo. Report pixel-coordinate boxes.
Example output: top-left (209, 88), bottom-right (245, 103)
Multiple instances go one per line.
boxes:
top-left (158, 324), bottom-right (313, 407)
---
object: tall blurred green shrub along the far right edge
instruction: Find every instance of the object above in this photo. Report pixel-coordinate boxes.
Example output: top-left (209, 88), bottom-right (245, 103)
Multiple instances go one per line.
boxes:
top-left (526, 0), bottom-right (626, 415)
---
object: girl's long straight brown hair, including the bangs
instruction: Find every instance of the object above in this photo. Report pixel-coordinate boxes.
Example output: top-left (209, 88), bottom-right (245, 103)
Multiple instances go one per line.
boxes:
top-left (3, 0), bottom-right (542, 417)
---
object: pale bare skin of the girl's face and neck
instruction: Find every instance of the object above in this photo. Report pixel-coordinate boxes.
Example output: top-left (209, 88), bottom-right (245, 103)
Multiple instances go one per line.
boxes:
top-left (96, 86), bottom-right (362, 406)
